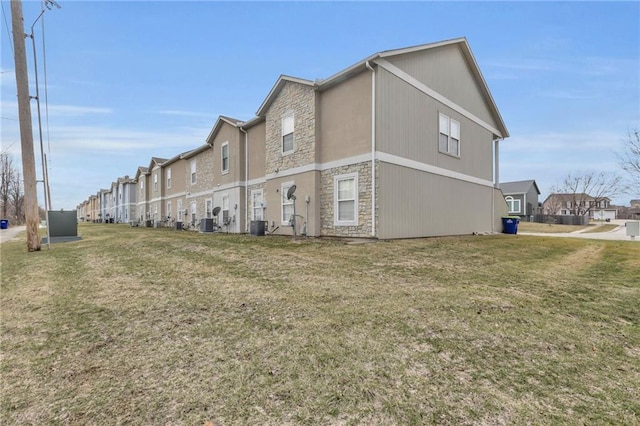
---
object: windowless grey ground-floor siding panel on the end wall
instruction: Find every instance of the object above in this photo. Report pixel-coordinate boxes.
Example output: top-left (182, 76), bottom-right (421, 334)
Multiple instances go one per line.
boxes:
top-left (378, 162), bottom-right (504, 239)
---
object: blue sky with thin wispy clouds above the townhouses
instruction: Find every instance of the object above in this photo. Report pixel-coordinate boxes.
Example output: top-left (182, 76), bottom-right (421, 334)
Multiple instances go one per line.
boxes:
top-left (0, 0), bottom-right (640, 209)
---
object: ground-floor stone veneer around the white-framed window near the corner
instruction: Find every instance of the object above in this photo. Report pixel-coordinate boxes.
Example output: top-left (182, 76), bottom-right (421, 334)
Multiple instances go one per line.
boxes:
top-left (320, 161), bottom-right (372, 237)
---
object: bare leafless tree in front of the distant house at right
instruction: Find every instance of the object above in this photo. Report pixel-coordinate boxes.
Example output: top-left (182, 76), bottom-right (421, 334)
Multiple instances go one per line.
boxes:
top-left (551, 170), bottom-right (624, 216)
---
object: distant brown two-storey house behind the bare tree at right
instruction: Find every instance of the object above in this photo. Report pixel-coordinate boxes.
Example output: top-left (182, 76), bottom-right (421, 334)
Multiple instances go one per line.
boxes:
top-left (542, 192), bottom-right (616, 220)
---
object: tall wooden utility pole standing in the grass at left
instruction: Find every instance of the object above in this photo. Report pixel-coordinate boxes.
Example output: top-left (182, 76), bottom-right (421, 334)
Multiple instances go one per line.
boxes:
top-left (11, 0), bottom-right (40, 252)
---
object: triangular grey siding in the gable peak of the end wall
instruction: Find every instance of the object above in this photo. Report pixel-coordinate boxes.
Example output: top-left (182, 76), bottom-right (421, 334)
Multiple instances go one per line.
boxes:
top-left (389, 44), bottom-right (499, 128)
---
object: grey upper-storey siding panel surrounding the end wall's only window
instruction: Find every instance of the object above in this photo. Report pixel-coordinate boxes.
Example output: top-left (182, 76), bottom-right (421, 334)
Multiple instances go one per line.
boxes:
top-left (376, 68), bottom-right (493, 181)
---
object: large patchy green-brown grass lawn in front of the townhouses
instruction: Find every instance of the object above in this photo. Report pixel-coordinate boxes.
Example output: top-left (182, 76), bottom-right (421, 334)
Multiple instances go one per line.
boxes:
top-left (0, 224), bottom-right (640, 426)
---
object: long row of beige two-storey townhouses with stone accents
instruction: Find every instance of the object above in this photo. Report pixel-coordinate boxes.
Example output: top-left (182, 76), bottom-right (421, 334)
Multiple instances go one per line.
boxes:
top-left (78, 38), bottom-right (508, 239)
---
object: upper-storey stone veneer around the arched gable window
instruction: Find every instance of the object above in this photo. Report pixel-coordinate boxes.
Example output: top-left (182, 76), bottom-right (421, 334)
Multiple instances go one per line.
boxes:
top-left (265, 82), bottom-right (316, 174)
